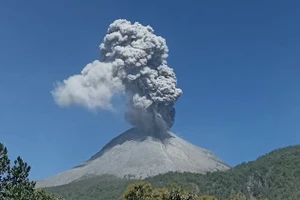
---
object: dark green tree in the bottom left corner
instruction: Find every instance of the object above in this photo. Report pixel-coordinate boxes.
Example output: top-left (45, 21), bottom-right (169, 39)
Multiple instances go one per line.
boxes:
top-left (0, 143), bottom-right (63, 200)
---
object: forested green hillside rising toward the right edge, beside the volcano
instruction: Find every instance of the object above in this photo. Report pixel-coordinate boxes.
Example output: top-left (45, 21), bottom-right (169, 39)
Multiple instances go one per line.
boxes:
top-left (149, 146), bottom-right (300, 200)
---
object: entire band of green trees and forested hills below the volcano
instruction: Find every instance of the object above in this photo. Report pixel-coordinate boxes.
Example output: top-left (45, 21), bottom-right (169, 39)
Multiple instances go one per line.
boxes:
top-left (0, 143), bottom-right (300, 200)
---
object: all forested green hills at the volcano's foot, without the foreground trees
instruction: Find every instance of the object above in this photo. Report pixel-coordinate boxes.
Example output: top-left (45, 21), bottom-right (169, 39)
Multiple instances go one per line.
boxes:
top-left (47, 145), bottom-right (300, 200)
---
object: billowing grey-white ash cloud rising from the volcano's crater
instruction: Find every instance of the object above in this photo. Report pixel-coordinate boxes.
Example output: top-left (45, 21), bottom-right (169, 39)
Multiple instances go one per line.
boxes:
top-left (52, 20), bottom-right (182, 133)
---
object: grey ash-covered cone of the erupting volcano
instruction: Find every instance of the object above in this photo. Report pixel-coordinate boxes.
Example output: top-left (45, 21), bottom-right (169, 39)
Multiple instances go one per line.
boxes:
top-left (36, 128), bottom-right (229, 188)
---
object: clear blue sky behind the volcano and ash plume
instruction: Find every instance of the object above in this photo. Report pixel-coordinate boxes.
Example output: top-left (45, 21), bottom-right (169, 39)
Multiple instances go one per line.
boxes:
top-left (0, 0), bottom-right (300, 179)
